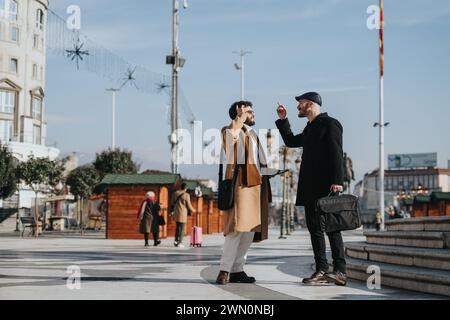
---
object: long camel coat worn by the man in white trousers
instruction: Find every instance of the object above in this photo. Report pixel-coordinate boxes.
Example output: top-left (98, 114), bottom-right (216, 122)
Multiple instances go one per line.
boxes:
top-left (222, 117), bottom-right (272, 242)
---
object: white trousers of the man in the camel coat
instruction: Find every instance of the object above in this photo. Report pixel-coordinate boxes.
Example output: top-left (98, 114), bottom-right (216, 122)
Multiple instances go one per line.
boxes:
top-left (220, 232), bottom-right (255, 273)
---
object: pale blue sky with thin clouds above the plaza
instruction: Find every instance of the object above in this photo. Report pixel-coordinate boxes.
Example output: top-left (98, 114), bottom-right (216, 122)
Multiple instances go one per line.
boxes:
top-left (46, 0), bottom-right (450, 185)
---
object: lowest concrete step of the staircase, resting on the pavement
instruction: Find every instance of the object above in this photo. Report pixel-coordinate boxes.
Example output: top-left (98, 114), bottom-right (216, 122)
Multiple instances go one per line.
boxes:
top-left (347, 259), bottom-right (450, 297)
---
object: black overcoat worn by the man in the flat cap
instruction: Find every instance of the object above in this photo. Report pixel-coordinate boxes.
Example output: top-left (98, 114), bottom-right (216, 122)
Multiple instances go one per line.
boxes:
top-left (276, 113), bottom-right (344, 206)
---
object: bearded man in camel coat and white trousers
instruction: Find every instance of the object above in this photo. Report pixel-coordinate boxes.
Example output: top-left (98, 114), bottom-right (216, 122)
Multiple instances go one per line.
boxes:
top-left (216, 101), bottom-right (272, 285)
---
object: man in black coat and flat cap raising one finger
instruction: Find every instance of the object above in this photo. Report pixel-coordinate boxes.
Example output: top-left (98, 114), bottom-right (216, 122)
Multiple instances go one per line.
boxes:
top-left (276, 92), bottom-right (347, 285)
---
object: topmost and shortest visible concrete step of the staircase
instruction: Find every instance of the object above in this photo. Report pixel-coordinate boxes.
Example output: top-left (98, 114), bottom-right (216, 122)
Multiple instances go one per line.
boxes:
top-left (385, 216), bottom-right (450, 232)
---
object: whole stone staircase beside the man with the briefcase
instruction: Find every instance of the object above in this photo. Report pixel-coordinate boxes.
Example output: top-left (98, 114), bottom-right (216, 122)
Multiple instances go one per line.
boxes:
top-left (345, 217), bottom-right (450, 296)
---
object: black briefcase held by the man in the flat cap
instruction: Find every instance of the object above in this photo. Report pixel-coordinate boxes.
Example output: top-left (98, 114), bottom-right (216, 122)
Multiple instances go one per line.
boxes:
top-left (316, 194), bottom-right (361, 232)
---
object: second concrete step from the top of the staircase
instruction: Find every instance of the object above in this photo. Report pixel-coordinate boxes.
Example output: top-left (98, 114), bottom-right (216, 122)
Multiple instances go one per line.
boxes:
top-left (364, 231), bottom-right (450, 249)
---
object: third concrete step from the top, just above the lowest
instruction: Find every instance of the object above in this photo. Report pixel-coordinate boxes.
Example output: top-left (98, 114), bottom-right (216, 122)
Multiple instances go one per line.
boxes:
top-left (345, 242), bottom-right (450, 271)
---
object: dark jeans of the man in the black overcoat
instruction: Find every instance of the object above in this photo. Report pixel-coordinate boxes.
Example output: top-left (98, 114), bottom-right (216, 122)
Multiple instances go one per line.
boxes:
top-left (305, 205), bottom-right (347, 274)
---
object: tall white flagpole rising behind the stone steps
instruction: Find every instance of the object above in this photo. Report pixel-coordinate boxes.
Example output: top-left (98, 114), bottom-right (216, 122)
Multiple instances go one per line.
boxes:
top-left (379, 0), bottom-right (385, 230)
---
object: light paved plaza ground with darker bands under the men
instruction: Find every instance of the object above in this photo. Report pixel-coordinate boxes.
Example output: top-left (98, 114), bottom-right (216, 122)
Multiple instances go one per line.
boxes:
top-left (0, 229), bottom-right (440, 300)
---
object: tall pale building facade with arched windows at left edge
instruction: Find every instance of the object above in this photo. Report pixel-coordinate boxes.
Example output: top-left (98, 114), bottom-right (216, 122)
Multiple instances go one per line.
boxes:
top-left (0, 0), bottom-right (59, 161)
